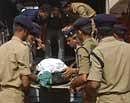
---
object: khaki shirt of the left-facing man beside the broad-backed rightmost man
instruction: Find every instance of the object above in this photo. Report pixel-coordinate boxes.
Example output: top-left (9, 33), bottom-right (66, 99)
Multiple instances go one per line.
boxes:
top-left (77, 38), bottom-right (97, 74)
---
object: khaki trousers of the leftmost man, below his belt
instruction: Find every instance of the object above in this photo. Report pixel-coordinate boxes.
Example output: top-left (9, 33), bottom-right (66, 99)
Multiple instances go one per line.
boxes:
top-left (0, 88), bottom-right (24, 103)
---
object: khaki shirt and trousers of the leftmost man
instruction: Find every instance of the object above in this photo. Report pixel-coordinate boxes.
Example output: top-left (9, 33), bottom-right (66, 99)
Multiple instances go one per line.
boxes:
top-left (0, 36), bottom-right (30, 103)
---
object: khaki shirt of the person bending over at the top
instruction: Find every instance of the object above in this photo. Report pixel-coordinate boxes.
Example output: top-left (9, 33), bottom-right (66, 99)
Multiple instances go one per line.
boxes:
top-left (71, 2), bottom-right (96, 17)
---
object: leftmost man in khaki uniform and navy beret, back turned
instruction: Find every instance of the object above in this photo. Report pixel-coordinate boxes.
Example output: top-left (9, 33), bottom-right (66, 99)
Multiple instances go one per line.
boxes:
top-left (0, 16), bottom-right (32, 103)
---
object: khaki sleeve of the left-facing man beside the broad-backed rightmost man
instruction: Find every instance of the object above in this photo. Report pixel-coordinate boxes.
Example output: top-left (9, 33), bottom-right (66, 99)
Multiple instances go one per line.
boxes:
top-left (78, 48), bottom-right (90, 74)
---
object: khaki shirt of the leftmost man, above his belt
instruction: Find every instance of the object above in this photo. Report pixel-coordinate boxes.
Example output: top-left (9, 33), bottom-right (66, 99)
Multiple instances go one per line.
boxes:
top-left (0, 36), bottom-right (30, 87)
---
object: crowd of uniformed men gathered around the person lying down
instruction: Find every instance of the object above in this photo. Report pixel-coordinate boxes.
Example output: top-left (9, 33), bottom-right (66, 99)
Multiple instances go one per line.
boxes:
top-left (0, 1), bottom-right (130, 103)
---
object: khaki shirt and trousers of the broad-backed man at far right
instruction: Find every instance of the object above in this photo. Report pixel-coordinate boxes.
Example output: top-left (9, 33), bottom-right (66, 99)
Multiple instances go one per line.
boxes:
top-left (88, 36), bottom-right (130, 103)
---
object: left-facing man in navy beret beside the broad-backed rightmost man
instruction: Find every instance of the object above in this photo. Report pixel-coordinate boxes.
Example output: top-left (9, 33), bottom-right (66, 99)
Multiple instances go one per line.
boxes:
top-left (70, 18), bottom-right (97, 82)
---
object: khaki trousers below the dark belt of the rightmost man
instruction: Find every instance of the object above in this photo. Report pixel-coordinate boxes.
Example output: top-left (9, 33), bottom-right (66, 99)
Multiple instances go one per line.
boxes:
top-left (96, 92), bottom-right (130, 103)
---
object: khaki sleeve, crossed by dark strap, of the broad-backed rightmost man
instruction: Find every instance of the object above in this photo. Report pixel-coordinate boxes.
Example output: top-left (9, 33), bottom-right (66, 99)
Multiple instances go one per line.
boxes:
top-left (87, 50), bottom-right (103, 81)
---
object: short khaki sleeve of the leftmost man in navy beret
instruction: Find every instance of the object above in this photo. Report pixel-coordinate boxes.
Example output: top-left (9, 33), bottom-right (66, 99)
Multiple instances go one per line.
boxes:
top-left (17, 47), bottom-right (31, 75)
